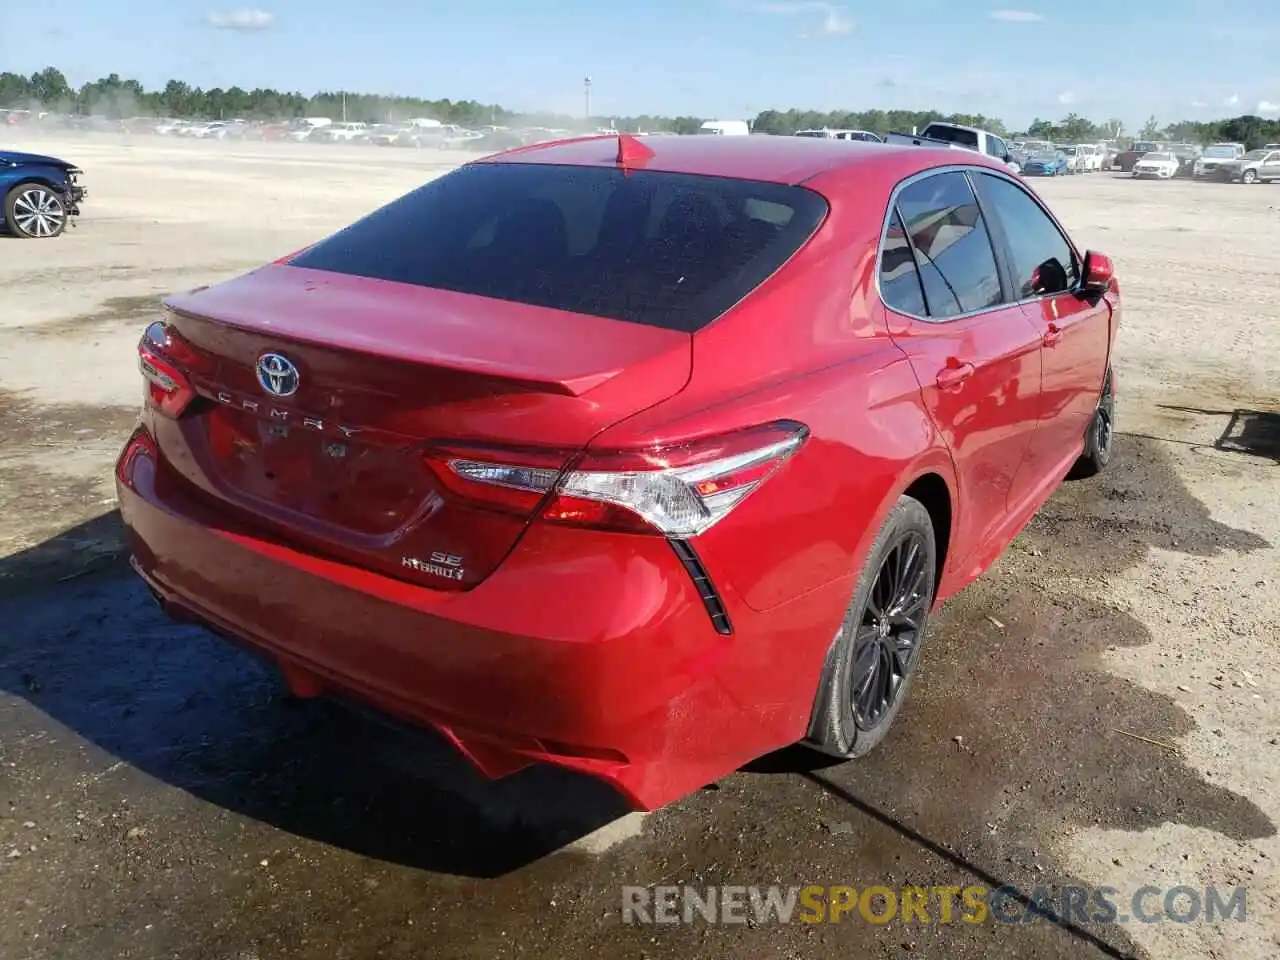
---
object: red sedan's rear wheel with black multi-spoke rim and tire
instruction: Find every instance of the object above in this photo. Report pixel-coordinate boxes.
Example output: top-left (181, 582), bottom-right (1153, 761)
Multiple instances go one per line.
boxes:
top-left (805, 497), bottom-right (937, 759)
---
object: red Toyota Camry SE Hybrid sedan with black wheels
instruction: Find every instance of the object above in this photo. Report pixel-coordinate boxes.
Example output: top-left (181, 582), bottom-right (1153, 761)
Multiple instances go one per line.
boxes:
top-left (116, 136), bottom-right (1120, 808)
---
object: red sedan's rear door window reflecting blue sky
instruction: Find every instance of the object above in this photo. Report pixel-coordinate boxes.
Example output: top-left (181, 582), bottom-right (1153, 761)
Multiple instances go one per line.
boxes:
top-left (897, 170), bottom-right (1004, 319)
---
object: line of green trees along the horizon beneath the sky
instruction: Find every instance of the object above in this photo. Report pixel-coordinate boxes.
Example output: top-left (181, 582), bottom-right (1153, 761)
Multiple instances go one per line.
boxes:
top-left (0, 67), bottom-right (1280, 148)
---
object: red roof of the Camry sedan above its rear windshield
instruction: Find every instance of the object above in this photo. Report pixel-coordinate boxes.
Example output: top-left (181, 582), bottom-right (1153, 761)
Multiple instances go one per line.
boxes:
top-left (475, 134), bottom-right (1002, 184)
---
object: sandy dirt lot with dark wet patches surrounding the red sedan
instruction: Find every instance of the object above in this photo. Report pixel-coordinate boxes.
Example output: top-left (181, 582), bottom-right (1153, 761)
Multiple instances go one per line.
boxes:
top-left (0, 137), bottom-right (1280, 960)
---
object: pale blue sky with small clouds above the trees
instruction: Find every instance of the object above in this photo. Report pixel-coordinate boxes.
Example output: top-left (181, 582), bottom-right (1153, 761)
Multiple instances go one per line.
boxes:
top-left (0, 0), bottom-right (1280, 128)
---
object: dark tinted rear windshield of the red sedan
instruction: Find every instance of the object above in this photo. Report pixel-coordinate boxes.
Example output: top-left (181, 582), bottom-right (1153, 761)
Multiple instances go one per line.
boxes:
top-left (292, 163), bottom-right (827, 333)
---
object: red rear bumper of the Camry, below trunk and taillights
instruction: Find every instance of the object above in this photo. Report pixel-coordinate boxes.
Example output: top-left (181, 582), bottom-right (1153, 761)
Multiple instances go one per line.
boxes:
top-left (116, 430), bottom-right (849, 809)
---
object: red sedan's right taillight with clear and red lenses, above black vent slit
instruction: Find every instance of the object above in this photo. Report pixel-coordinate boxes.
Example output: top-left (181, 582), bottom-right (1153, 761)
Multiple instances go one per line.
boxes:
top-left (430, 421), bottom-right (808, 538)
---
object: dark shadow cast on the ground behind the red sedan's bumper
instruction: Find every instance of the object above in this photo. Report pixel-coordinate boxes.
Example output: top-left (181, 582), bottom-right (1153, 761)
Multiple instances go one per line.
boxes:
top-left (0, 512), bottom-right (625, 877)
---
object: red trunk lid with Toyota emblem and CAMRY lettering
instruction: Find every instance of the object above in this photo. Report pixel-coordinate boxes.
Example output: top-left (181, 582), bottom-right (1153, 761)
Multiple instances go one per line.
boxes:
top-left (155, 265), bottom-right (691, 589)
